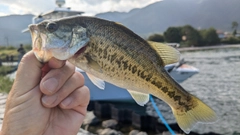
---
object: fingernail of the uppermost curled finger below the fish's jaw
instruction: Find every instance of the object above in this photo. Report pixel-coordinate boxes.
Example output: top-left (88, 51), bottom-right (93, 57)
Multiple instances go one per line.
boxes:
top-left (43, 78), bottom-right (58, 93)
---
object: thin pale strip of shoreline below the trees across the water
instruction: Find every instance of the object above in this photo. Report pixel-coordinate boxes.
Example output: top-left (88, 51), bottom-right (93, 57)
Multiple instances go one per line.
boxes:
top-left (177, 44), bottom-right (240, 52)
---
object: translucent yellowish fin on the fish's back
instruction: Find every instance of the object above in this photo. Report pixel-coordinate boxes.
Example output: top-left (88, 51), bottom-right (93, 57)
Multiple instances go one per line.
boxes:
top-left (148, 41), bottom-right (180, 66)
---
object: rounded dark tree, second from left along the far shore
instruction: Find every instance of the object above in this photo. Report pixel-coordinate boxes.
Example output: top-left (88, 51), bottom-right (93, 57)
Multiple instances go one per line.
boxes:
top-left (164, 27), bottom-right (182, 43)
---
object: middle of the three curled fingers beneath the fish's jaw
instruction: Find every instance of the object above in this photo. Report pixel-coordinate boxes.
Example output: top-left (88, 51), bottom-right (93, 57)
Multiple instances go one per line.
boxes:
top-left (42, 72), bottom-right (84, 108)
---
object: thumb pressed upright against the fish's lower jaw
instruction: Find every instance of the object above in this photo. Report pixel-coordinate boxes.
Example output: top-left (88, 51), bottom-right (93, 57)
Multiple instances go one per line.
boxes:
top-left (11, 51), bottom-right (43, 95)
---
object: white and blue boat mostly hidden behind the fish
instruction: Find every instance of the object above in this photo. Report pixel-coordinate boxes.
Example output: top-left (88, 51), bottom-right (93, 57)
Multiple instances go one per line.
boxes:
top-left (22, 0), bottom-right (199, 102)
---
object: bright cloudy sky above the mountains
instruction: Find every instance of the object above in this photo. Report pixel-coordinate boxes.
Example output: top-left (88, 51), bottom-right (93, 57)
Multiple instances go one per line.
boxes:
top-left (0, 0), bottom-right (160, 16)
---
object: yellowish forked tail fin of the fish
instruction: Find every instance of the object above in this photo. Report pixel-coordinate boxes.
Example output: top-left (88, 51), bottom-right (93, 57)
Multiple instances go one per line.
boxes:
top-left (172, 96), bottom-right (217, 134)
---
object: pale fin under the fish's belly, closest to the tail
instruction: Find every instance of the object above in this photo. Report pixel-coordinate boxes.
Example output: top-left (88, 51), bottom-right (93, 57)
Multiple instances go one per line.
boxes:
top-left (128, 90), bottom-right (149, 106)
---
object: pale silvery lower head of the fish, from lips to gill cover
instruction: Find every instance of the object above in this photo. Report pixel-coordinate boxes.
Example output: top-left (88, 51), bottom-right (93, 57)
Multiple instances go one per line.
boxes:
top-left (29, 24), bottom-right (89, 63)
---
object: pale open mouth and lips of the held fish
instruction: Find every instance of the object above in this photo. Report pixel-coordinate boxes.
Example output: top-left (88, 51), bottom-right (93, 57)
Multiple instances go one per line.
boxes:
top-left (29, 24), bottom-right (53, 63)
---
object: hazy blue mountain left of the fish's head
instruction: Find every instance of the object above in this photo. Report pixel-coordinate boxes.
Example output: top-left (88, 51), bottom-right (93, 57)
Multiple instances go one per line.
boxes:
top-left (0, 14), bottom-right (33, 46)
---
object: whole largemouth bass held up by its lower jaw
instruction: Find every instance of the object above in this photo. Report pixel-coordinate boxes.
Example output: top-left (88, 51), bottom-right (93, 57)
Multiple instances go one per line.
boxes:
top-left (29, 16), bottom-right (217, 134)
